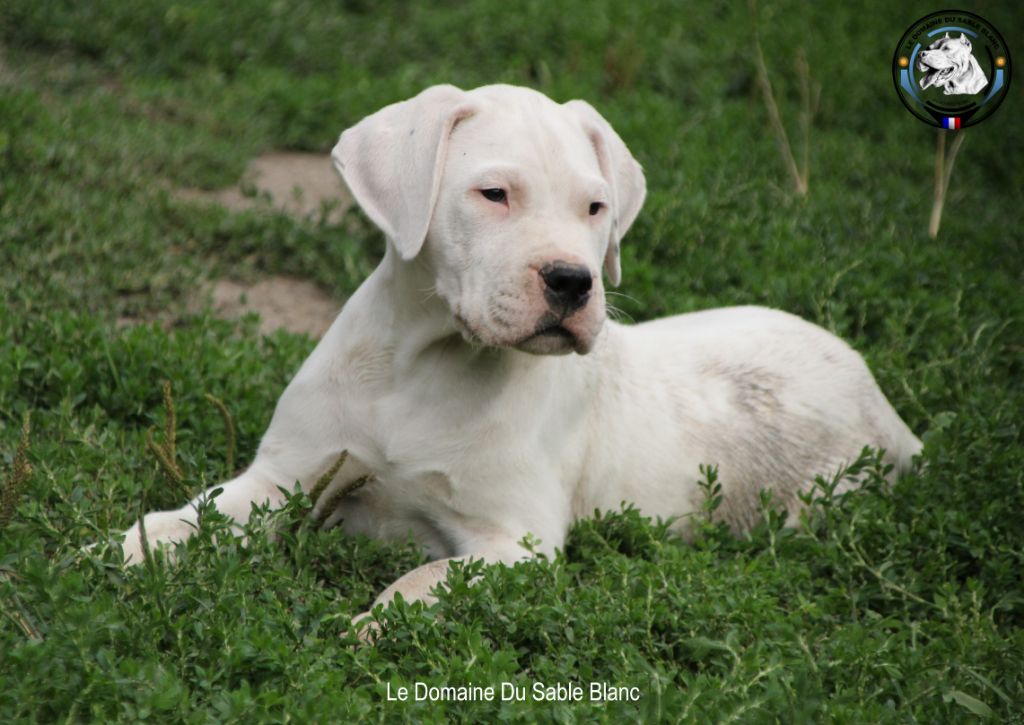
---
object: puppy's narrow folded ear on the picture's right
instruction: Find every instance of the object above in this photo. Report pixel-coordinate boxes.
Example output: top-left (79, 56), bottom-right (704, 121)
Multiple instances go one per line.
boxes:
top-left (565, 100), bottom-right (647, 286)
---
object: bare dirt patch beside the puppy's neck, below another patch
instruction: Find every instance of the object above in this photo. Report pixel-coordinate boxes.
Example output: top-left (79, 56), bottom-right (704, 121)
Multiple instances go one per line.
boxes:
top-left (201, 276), bottom-right (341, 338)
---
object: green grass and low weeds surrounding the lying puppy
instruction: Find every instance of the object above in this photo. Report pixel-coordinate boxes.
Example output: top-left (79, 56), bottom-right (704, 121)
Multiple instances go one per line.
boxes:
top-left (0, 0), bottom-right (1024, 723)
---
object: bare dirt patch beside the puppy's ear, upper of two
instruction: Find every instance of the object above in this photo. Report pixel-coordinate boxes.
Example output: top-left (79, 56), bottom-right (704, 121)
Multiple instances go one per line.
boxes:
top-left (173, 152), bottom-right (352, 224)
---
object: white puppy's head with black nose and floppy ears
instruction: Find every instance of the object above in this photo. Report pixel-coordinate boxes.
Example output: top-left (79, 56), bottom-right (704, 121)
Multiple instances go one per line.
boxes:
top-left (332, 85), bottom-right (646, 354)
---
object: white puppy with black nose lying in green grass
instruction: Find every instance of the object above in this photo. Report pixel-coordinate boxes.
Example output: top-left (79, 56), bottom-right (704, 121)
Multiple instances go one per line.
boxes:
top-left (116, 86), bottom-right (921, 618)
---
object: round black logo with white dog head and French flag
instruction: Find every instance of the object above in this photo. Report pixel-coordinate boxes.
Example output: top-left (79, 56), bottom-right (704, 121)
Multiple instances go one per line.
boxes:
top-left (893, 10), bottom-right (1012, 129)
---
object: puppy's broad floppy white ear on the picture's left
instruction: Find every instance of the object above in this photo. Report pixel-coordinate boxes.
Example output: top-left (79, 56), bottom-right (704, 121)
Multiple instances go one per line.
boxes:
top-left (331, 85), bottom-right (475, 261)
